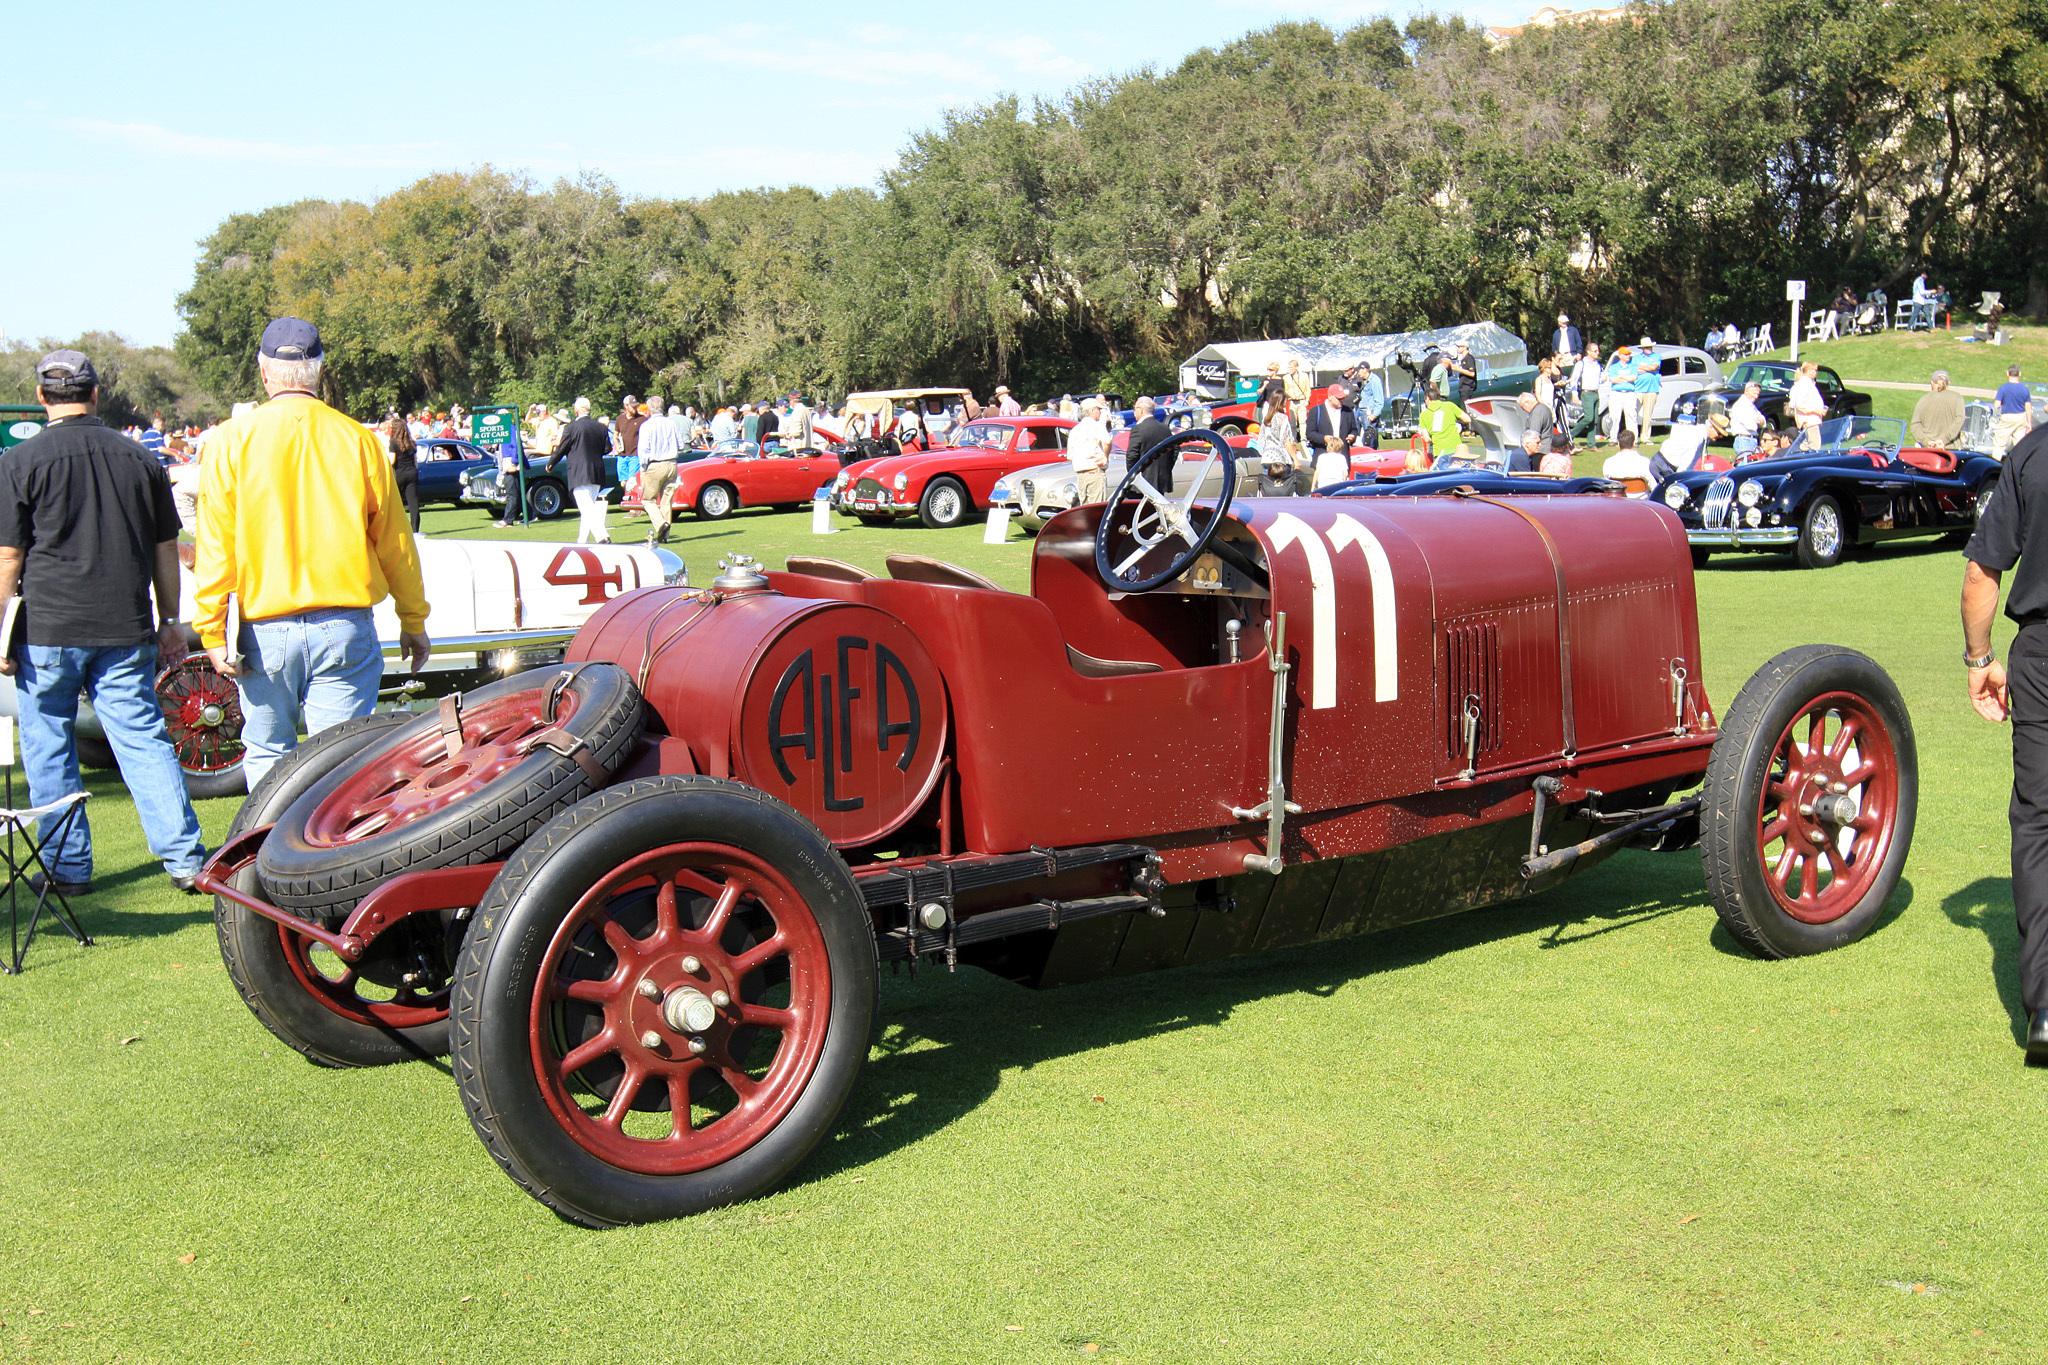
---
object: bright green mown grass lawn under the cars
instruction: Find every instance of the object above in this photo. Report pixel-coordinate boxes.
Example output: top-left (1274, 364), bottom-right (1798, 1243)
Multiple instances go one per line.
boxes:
top-left (0, 344), bottom-right (2048, 1365)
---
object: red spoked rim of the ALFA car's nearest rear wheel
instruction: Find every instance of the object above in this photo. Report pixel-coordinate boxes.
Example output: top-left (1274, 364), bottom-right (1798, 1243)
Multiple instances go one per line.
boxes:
top-left (530, 843), bottom-right (831, 1175)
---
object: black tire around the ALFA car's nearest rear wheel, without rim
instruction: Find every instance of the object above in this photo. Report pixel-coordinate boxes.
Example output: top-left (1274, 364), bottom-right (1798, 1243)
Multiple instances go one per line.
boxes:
top-left (453, 778), bottom-right (877, 1228)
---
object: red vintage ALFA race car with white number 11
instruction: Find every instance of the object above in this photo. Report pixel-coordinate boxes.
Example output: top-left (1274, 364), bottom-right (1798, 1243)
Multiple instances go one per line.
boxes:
top-left (203, 434), bottom-right (1917, 1226)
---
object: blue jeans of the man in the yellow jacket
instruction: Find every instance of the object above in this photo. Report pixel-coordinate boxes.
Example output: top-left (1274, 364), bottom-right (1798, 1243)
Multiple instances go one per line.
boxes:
top-left (236, 606), bottom-right (383, 792)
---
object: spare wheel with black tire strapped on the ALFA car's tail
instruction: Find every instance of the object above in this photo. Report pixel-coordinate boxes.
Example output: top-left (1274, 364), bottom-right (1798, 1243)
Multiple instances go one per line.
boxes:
top-left (256, 663), bottom-right (643, 919)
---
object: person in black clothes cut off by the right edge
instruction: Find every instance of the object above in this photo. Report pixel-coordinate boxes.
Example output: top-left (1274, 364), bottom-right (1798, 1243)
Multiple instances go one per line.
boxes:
top-left (1962, 428), bottom-right (2048, 1066)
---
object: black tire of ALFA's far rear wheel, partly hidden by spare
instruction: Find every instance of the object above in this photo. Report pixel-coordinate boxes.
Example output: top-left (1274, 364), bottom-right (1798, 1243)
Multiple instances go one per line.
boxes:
top-left (213, 712), bottom-right (449, 1066)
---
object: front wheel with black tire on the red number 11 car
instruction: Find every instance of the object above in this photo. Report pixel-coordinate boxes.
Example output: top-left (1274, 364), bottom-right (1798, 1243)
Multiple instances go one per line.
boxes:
top-left (1700, 645), bottom-right (1919, 958)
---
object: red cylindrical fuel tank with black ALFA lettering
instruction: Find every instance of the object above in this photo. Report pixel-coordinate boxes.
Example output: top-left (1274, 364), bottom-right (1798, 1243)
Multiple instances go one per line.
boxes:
top-left (567, 587), bottom-right (948, 847)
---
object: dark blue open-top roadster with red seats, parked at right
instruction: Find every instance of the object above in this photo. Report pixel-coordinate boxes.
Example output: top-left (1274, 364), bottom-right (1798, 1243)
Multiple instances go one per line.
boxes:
top-left (1651, 417), bottom-right (2001, 569)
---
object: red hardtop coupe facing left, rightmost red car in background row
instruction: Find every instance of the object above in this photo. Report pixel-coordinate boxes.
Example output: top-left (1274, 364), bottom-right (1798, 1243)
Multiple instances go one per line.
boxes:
top-left (838, 417), bottom-right (1073, 526)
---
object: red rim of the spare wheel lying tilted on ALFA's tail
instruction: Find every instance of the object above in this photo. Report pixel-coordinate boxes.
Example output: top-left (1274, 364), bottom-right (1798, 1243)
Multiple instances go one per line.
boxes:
top-left (292, 688), bottom-right (575, 847)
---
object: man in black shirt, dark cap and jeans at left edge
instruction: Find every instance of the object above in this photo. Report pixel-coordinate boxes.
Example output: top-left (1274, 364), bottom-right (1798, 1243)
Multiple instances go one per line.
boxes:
top-left (0, 350), bottom-right (207, 896)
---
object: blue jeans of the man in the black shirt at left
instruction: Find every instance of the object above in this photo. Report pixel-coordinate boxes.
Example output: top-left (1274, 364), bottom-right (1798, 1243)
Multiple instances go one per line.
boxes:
top-left (14, 645), bottom-right (207, 882)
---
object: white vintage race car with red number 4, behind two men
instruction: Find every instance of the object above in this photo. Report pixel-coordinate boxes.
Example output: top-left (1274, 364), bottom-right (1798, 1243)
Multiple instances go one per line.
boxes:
top-left (0, 540), bottom-right (688, 796)
